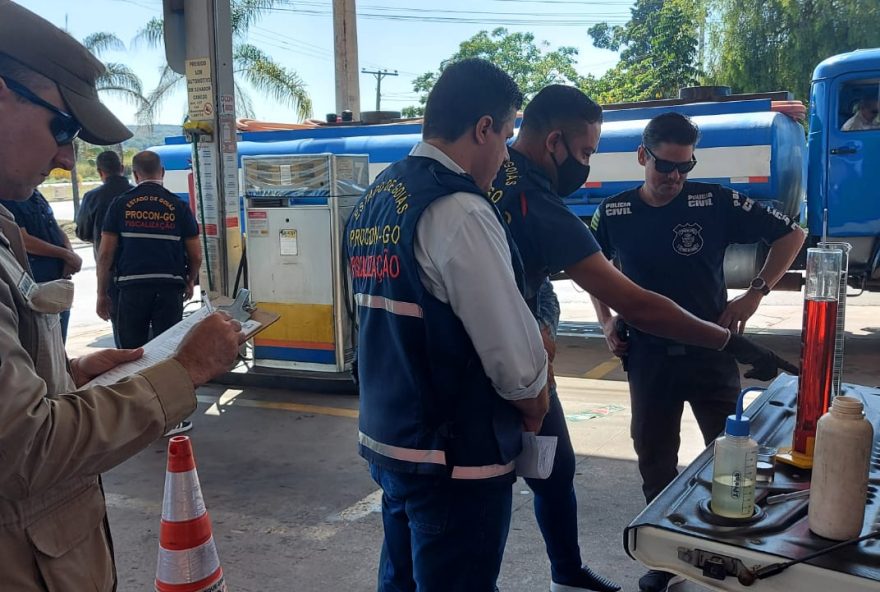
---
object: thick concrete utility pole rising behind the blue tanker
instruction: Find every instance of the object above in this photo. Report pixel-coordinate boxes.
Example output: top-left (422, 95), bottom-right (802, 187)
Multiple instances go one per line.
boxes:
top-left (333, 0), bottom-right (361, 121)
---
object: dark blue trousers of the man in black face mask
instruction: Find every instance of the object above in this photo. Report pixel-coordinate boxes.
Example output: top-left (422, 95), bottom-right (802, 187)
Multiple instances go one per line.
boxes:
top-left (526, 388), bottom-right (581, 582)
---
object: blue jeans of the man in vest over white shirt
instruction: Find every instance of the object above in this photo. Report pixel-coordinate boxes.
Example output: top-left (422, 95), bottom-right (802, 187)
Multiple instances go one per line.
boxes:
top-left (370, 464), bottom-right (512, 592)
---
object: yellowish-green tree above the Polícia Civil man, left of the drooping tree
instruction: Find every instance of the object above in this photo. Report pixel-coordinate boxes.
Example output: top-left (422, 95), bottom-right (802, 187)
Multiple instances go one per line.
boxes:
top-left (581, 0), bottom-right (706, 103)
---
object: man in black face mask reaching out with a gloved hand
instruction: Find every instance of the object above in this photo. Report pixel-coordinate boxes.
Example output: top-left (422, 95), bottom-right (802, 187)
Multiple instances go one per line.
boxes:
top-left (490, 85), bottom-right (797, 592)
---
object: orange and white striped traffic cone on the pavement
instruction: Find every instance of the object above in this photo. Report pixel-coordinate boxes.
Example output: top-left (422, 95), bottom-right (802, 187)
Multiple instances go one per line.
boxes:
top-left (156, 436), bottom-right (226, 592)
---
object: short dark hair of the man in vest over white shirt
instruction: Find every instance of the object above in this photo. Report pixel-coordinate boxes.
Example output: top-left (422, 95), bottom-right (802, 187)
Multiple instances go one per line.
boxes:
top-left (422, 58), bottom-right (523, 142)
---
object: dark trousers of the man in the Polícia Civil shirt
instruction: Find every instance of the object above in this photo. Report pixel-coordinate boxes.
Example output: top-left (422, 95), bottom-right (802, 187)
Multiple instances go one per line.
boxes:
top-left (629, 336), bottom-right (740, 503)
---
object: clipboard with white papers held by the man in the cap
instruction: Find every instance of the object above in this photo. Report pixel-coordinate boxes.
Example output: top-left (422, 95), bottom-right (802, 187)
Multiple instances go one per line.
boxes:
top-left (80, 298), bottom-right (280, 388)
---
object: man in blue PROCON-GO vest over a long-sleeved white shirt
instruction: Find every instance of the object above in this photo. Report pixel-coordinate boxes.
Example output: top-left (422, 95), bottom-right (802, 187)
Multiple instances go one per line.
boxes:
top-left (345, 59), bottom-right (547, 592)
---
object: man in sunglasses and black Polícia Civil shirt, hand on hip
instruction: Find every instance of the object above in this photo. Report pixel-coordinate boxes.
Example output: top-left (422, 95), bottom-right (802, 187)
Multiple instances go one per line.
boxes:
top-left (592, 112), bottom-right (804, 592)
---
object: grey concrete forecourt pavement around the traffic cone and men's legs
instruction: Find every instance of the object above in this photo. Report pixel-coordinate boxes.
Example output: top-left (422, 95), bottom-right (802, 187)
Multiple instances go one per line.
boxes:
top-left (58, 245), bottom-right (880, 592)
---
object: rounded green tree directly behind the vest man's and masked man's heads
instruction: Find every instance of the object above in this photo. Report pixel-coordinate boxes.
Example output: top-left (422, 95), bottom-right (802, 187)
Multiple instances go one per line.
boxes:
top-left (403, 27), bottom-right (581, 117)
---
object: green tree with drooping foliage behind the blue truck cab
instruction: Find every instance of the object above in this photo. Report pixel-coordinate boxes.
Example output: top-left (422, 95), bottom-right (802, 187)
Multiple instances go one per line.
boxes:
top-left (707, 0), bottom-right (880, 100)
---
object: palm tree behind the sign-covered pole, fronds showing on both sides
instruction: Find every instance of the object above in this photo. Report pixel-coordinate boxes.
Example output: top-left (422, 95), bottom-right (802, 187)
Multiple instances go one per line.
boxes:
top-left (135, 0), bottom-right (312, 121)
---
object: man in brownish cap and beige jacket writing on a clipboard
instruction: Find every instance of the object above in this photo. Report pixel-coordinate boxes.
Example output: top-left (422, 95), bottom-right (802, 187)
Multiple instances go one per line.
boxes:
top-left (0, 0), bottom-right (241, 592)
